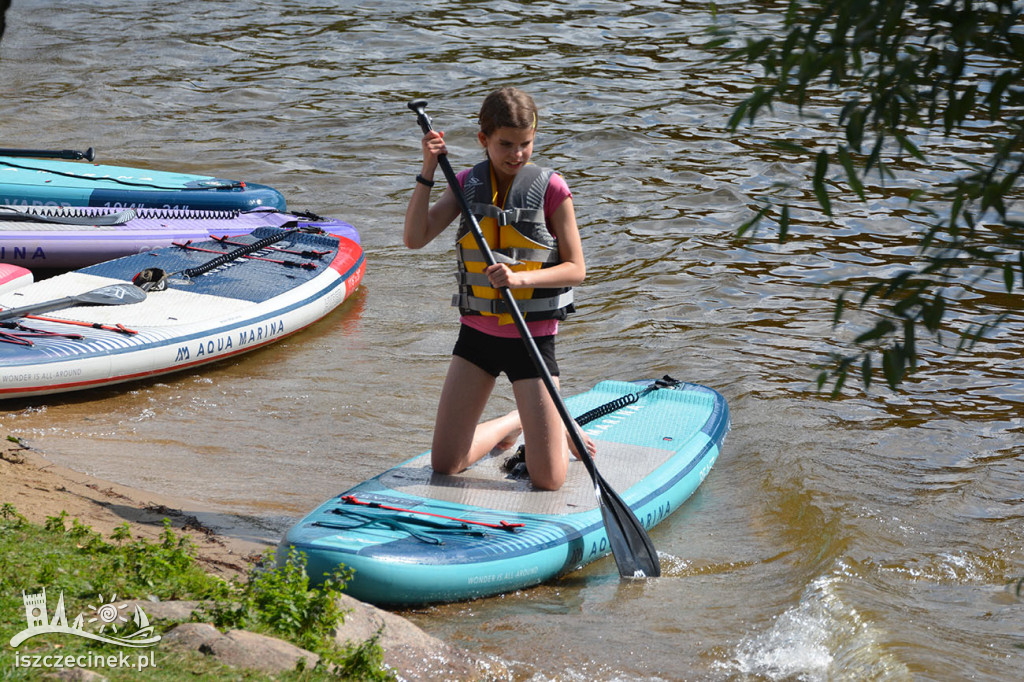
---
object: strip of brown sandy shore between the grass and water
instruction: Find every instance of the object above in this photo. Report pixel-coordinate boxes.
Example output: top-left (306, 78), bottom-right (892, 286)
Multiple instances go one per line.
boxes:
top-left (0, 439), bottom-right (274, 577)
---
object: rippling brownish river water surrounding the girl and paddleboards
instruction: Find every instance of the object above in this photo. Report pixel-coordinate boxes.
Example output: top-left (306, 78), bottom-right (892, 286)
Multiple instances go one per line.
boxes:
top-left (0, 0), bottom-right (1024, 680)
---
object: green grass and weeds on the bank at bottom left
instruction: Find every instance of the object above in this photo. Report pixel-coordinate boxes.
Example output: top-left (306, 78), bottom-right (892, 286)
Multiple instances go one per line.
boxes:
top-left (0, 504), bottom-right (394, 680)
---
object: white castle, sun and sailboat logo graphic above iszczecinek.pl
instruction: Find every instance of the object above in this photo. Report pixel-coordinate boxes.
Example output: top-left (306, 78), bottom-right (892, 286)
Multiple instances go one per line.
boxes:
top-left (10, 588), bottom-right (160, 648)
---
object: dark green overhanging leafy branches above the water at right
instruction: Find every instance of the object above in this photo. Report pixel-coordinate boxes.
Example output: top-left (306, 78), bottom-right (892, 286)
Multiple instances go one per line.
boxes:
top-left (728, 0), bottom-right (1024, 394)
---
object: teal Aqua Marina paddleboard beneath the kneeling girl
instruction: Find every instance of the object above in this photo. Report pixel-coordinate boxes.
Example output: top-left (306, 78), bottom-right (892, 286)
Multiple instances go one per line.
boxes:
top-left (278, 380), bottom-right (729, 606)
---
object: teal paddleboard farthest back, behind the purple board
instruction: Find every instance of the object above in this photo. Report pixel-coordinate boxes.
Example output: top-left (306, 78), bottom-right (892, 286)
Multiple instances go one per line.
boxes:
top-left (0, 156), bottom-right (287, 211)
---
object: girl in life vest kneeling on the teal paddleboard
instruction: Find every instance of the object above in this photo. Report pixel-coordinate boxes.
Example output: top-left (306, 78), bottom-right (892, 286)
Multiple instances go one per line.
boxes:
top-left (404, 88), bottom-right (595, 491)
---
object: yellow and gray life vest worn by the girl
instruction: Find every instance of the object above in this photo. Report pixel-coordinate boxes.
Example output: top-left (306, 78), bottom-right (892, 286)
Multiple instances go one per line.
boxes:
top-left (452, 161), bottom-right (575, 325)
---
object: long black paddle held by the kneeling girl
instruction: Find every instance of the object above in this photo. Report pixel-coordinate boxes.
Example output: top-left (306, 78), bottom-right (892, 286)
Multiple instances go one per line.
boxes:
top-left (409, 99), bottom-right (662, 578)
